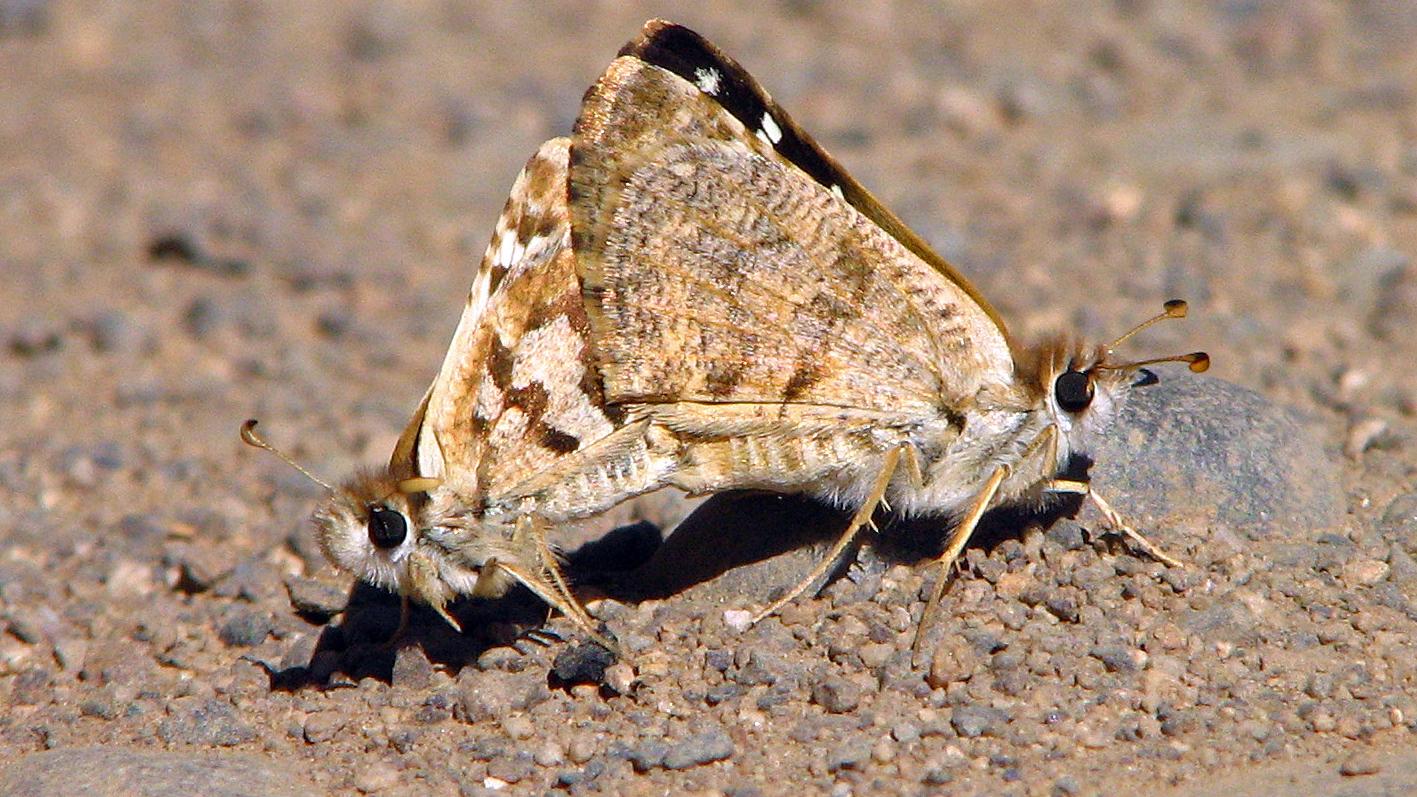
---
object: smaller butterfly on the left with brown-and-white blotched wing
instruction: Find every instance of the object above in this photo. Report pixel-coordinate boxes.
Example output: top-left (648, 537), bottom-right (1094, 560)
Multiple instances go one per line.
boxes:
top-left (241, 138), bottom-right (670, 647)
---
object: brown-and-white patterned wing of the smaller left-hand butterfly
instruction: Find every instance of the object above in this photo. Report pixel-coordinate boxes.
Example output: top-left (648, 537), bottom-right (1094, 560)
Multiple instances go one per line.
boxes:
top-left (395, 139), bottom-right (616, 502)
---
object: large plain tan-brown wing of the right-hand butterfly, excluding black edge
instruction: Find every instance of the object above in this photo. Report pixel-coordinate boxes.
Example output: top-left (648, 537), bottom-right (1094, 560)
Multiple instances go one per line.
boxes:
top-left (571, 40), bottom-right (1012, 418)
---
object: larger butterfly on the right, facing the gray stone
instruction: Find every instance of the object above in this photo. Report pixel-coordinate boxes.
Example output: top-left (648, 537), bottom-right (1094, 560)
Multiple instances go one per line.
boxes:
top-left (570, 20), bottom-right (1209, 641)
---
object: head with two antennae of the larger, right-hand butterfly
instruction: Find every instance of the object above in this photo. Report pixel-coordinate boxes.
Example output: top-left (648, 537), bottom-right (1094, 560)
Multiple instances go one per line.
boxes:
top-left (1027, 299), bottom-right (1210, 468)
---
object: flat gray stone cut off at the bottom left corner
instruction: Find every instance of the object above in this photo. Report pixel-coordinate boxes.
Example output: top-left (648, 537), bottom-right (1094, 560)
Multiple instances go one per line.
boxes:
top-left (0, 747), bottom-right (319, 797)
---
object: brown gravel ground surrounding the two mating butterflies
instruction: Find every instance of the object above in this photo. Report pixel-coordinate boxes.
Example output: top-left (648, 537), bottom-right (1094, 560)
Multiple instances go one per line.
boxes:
top-left (0, 0), bottom-right (1417, 797)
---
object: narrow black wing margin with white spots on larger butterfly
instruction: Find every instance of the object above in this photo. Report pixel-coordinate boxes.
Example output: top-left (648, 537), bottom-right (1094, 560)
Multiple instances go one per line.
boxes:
top-left (619, 20), bottom-right (1009, 339)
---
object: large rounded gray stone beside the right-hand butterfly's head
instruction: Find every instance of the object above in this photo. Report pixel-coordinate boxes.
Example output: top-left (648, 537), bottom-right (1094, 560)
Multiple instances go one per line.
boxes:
top-left (1091, 372), bottom-right (1348, 536)
